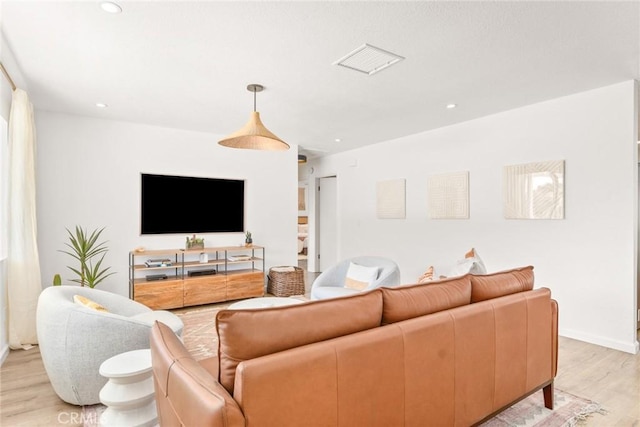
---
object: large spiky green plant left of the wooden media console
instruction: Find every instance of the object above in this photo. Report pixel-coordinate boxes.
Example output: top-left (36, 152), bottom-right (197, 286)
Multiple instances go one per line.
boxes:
top-left (60, 226), bottom-right (115, 288)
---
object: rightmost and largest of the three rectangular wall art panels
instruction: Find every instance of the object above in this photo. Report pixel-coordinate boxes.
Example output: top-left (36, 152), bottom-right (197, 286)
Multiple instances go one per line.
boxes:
top-left (502, 160), bottom-right (564, 219)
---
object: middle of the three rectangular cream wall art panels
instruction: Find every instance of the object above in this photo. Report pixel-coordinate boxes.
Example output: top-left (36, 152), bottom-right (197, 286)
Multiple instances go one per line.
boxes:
top-left (427, 171), bottom-right (469, 219)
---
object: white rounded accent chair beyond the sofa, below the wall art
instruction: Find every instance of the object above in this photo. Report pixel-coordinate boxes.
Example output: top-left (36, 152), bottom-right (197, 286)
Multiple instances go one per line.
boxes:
top-left (311, 256), bottom-right (400, 300)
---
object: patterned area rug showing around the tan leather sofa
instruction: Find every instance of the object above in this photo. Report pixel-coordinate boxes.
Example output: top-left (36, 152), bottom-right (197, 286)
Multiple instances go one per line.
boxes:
top-left (82, 305), bottom-right (606, 427)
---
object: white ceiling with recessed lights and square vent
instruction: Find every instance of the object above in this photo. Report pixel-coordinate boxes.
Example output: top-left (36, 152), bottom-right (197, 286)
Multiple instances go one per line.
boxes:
top-left (0, 0), bottom-right (640, 154)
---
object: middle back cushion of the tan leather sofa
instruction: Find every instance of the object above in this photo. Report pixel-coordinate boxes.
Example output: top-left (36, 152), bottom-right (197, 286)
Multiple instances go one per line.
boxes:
top-left (382, 275), bottom-right (471, 324)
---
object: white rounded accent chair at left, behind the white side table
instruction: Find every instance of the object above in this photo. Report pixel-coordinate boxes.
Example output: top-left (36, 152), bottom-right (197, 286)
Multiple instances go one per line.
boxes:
top-left (36, 286), bottom-right (184, 405)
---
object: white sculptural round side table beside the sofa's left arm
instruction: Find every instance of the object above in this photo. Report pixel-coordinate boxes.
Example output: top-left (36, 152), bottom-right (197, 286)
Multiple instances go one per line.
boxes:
top-left (100, 349), bottom-right (158, 427)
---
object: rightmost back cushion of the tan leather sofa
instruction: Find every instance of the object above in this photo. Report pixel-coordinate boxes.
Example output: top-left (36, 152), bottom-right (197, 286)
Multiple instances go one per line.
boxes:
top-left (470, 265), bottom-right (533, 303)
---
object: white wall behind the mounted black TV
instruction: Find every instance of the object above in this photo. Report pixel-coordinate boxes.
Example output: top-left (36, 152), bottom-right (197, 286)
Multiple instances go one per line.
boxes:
top-left (36, 111), bottom-right (298, 295)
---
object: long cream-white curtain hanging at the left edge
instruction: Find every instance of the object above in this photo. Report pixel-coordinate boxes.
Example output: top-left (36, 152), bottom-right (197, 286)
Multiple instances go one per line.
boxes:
top-left (7, 89), bottom-right (42, 349)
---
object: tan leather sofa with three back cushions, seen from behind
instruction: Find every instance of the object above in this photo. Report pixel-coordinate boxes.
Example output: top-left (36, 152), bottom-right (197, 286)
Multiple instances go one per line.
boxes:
top-left (151, 267), bottom-right (558, 427)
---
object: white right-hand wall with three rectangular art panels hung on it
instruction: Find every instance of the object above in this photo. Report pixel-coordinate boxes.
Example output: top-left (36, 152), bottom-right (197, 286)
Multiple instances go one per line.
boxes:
top-left (308, 81), bottom-right (638, 353)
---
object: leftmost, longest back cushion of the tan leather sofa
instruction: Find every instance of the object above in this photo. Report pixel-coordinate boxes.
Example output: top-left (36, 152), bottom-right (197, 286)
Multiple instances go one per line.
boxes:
top-left (216, 289), bottom-right (382, 393)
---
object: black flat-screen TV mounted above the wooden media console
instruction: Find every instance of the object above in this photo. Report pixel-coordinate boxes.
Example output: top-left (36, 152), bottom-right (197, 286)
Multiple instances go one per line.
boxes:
top-left (140, 174), bottom-right (244, 234)
